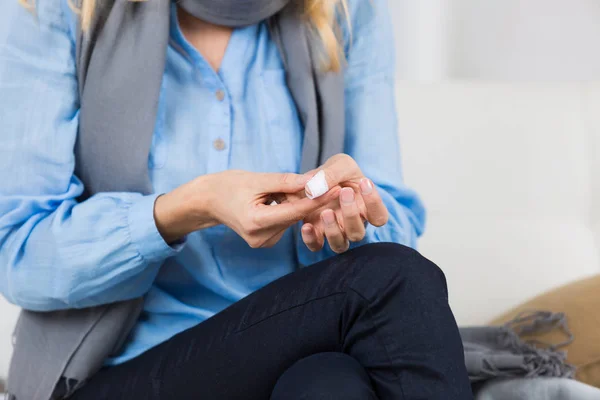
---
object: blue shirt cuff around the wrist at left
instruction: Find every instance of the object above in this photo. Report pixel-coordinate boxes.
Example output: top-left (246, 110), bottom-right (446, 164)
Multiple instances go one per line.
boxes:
top-left (128, 194), bottom-right (185, 262)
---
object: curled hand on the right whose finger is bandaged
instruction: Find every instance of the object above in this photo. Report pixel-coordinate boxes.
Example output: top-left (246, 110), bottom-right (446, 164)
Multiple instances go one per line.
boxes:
top-left (302, 154), bottom-right (388, 253)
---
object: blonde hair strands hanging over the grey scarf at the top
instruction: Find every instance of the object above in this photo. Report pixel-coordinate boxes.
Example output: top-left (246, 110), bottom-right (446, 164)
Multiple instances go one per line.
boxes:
top-left (18, 0), bottom-right (350, 72)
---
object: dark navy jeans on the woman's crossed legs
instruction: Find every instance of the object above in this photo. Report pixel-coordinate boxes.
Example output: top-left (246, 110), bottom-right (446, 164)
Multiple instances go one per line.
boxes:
top-left (74, 244), bottom-right (472, 400)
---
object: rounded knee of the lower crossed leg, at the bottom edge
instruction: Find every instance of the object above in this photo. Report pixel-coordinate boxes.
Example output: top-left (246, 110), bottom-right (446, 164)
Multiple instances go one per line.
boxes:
top-left (271, 353), bottom-right (378, 400)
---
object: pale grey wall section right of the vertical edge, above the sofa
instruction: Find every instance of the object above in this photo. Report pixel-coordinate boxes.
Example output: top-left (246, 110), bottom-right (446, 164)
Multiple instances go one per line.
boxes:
top-left (449, 0), bottom-right (600, 80)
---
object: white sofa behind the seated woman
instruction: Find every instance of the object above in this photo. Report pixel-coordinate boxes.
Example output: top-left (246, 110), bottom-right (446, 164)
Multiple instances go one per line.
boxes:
top-left (0, 82), bottom-right (600, 377)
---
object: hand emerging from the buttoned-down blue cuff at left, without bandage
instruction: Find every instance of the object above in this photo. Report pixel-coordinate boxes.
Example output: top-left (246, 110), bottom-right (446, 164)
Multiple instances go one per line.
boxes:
top-left (154, 170), bottom-right (339, 248)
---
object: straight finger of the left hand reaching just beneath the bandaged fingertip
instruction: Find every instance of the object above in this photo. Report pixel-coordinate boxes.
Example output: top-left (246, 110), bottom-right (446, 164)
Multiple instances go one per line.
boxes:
top-left (255, 188), bottom-right (339, 228)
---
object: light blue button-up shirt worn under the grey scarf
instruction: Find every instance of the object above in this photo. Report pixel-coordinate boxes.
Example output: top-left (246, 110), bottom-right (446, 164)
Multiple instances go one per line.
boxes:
top-left (0, 0), bottom-right (424, 364)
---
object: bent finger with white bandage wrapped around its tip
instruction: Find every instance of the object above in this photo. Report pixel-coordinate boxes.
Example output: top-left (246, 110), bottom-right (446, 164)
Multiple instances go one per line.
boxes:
top-left (305, 154), bottom-right (362, 198)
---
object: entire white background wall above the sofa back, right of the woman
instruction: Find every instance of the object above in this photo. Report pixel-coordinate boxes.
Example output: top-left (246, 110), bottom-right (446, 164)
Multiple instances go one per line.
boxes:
top-left (389, 0), bottom-right (600, 81)
